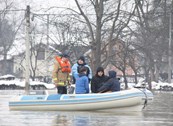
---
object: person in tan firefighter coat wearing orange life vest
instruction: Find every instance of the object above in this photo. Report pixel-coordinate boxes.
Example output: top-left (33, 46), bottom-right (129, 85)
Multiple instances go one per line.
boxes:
top-left (52, 53), bottom-right (71, 94)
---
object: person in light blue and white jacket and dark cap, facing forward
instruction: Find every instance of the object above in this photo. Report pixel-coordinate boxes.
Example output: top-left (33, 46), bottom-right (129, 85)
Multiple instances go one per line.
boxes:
top-left (72, 56), bottom-right (92, 84)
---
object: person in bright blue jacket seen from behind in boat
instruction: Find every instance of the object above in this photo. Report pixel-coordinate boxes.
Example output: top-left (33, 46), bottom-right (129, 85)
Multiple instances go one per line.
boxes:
top-left (74, 66), bottom-right (89, 94)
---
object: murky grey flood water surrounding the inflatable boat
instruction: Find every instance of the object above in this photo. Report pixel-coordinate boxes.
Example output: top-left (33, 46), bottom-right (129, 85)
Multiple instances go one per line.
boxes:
top-left (0, 90), bottom-right (173, 126)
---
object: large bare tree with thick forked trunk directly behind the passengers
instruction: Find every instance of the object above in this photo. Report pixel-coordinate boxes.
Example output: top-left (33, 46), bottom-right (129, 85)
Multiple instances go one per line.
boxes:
top-left (75, 0), bottom-right (136, 73)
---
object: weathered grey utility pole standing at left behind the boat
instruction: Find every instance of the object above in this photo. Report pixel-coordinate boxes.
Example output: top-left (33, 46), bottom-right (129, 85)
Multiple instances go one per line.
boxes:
top-left (25, 6), bottom-right (30, 95)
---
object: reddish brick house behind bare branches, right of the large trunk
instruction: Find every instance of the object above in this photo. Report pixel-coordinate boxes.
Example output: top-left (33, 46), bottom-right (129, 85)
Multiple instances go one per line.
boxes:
top-left (85, 39), bottom-right (139, 82)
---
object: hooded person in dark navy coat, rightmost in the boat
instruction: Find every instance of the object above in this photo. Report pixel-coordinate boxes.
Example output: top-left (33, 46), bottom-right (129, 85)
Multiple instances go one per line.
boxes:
top-left (98, 70), bottom-right (120, 93)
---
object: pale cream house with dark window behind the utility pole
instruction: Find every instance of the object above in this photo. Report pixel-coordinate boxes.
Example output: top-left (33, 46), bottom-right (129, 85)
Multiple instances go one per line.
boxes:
top-left (13, 44), bottom-right (60, 80)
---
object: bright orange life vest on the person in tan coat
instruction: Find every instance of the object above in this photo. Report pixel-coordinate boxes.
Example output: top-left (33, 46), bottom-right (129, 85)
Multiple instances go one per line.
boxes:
top-left (55, 56), bottom-right (71, 73)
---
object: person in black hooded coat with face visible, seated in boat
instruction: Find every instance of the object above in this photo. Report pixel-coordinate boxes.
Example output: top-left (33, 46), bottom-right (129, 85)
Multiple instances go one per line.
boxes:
top-left (91, 67), bottom-right (109, 93)
